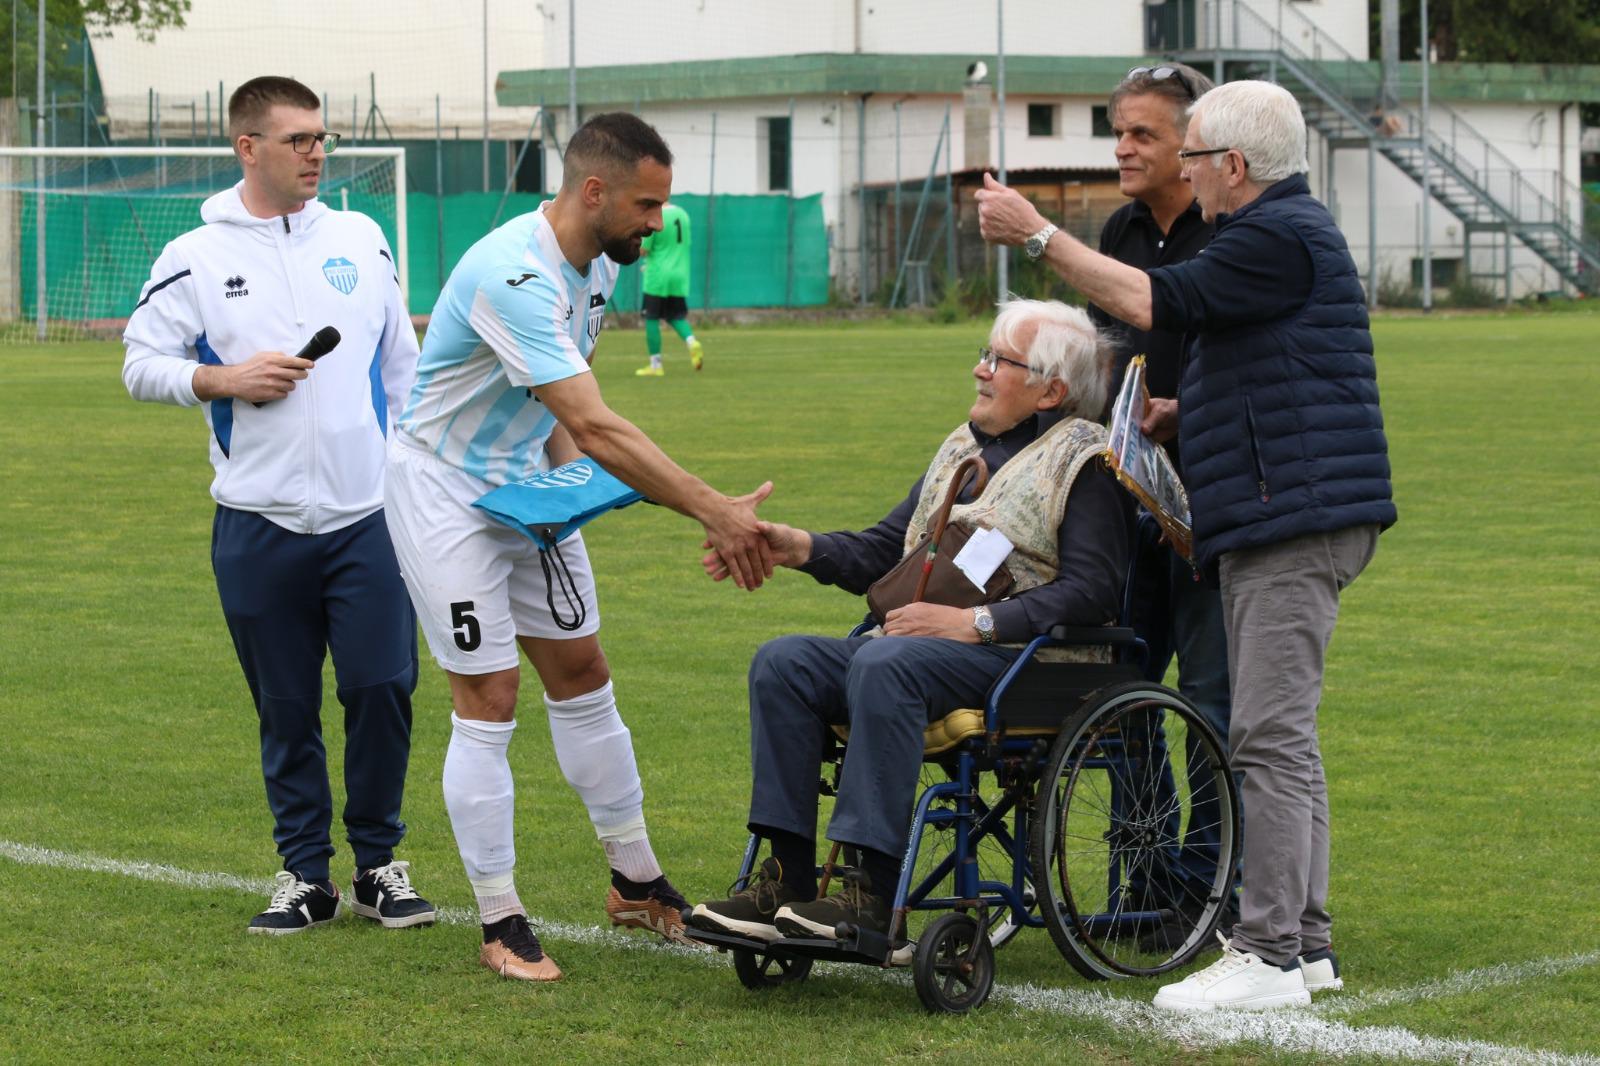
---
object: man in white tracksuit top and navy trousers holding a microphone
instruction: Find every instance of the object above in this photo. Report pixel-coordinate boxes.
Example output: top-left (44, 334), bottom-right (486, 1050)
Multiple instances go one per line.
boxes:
top-left (123, 77), bottom-right (435, 935)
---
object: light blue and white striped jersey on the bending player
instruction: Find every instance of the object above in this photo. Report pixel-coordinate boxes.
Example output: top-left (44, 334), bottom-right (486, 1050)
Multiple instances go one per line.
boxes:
top-left (398, 202), bottom-right (618, 485)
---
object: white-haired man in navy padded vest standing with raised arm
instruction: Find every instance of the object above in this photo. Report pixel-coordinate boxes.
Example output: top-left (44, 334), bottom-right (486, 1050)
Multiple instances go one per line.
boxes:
top-left (978, 82), bottom-right (1395, 1010)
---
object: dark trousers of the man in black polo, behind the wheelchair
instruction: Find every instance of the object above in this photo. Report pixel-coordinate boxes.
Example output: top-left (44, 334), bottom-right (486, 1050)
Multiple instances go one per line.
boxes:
top-left (1133, 514), bottom-right (1230, 896)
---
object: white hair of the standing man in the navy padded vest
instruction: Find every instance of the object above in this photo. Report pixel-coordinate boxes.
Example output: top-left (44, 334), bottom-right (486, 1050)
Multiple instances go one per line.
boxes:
top-left (1189, 82), bottom-right (1310, 186)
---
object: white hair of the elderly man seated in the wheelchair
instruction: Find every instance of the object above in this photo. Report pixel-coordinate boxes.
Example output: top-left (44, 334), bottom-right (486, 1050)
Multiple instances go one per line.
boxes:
top-left (989, 298), bottom-right (1110, 419)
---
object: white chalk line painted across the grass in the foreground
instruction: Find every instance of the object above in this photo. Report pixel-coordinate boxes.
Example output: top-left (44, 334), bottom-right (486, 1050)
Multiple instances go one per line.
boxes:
top-left (0, 840), bottom-right (1600, 1066)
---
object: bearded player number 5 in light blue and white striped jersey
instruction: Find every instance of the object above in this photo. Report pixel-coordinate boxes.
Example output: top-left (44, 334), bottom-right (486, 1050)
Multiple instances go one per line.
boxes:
top-left (386, 114), bottom-right (773, 981)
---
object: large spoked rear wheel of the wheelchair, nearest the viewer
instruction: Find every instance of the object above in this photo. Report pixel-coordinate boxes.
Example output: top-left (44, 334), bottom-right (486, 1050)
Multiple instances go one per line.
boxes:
top-left (1030, 682), bottom-right (1238, 980)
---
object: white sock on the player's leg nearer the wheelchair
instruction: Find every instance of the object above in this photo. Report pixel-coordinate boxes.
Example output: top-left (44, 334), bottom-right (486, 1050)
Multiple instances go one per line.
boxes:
top-left (544, 682), bottom-right (661, 857)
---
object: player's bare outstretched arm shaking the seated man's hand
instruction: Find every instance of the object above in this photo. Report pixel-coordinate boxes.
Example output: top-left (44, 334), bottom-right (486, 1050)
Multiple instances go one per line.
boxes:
top-left (534, 375), bottom-right (773, 589)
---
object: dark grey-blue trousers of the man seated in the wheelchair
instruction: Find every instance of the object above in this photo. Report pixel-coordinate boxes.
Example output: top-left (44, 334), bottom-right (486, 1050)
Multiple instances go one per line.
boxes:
top-left (750, 637), bottom-right (1021, 855)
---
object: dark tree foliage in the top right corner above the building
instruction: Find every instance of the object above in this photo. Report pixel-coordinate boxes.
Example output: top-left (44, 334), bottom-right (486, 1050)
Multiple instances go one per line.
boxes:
top-left (1371, 0), bottom-right (1600, 64)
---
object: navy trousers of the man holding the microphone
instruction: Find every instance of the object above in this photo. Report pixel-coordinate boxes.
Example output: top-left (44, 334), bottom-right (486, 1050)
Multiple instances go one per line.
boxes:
top-left (211, 507), bottom-right (418, 880)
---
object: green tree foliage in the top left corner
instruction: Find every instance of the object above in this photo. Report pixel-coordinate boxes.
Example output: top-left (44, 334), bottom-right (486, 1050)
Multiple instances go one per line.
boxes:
top-left (0, 0), bottom-right (190, 96)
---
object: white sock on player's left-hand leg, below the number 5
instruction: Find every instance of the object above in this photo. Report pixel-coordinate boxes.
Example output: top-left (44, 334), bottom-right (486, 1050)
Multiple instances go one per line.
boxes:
top-left (443, 714), bottom-right (523, 924)
